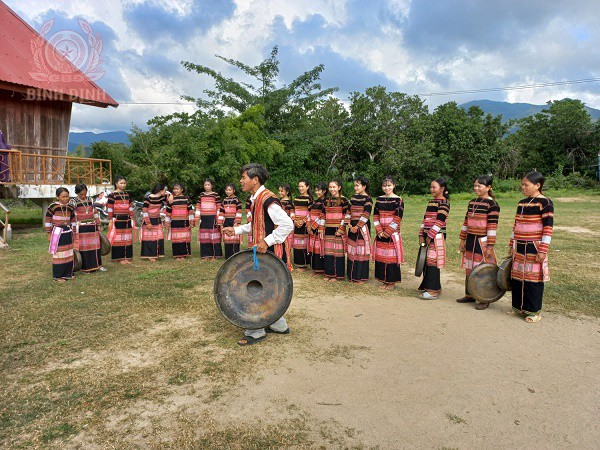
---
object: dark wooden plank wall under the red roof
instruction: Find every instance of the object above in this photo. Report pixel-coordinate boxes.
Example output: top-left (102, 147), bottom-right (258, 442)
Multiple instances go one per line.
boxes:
top-left (0, 89), bottom-right (72, 156)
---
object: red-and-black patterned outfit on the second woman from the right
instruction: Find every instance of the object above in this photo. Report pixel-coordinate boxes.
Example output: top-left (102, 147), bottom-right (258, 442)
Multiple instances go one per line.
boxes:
top-left (460, 198), bottom-right (500, 275)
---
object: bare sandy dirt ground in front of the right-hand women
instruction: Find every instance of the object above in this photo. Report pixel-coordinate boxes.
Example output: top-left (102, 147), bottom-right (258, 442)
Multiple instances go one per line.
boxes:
top-left (213, 270), bottom-right (600, 449)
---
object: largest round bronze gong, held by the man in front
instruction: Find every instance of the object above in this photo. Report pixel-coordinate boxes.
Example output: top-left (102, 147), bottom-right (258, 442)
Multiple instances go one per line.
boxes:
top-left (214, 250), bottom-right (294, 329)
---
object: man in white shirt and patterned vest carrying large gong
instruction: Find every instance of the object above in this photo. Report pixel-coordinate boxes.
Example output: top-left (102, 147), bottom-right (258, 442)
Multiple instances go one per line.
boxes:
top-left (223, 163), bottom-right (294, 346)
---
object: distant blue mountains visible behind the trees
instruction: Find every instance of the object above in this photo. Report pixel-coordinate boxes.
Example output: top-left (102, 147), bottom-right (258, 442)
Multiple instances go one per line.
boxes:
top-left (69, 100), bottom-right (600, 152)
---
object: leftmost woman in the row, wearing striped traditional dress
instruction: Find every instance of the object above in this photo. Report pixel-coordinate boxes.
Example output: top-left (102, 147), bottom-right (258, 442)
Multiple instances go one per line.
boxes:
top-left (45, 187), bottom-right (76, 282)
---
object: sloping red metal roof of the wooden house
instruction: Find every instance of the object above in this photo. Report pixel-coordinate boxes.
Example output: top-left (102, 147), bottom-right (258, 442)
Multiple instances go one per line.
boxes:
top-left (0, 0), bottom-right (119, 108)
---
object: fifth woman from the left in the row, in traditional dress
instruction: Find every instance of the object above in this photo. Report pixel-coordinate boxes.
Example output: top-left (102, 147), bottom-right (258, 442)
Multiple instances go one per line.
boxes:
top-left (165, 183), bottom-right (194, 261)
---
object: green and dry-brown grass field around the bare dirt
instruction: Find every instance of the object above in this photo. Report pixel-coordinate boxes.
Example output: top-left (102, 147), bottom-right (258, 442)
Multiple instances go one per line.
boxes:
top-left (0, 192), bottom-right (600, 449)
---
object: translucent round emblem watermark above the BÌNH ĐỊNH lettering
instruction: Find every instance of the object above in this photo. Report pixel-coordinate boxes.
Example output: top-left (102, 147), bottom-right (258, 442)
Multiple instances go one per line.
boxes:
top-left (29, 19), bottom-right (104, 82)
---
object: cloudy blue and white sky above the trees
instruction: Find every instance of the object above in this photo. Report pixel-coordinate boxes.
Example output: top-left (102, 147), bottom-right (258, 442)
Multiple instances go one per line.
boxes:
top-left (4, 0), bottom-right (600, 131)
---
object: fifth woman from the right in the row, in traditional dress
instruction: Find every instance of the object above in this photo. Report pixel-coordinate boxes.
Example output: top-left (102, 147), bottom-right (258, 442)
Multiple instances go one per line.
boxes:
top-left (346, 177), bottom-right (373, 284)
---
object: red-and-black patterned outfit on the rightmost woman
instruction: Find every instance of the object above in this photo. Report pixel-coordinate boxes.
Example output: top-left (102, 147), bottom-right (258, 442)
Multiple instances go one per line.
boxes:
top-left (510, 197), bottom-right (554, 282)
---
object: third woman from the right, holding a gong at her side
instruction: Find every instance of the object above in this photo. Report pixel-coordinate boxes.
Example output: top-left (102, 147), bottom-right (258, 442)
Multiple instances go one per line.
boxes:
top-left (419, 178), bottom-right (450, 300)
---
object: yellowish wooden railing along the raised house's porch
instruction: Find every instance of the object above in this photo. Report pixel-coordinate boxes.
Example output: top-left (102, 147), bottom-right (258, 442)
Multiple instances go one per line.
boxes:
top-left (0, 150), bottom-right (112, 185)
